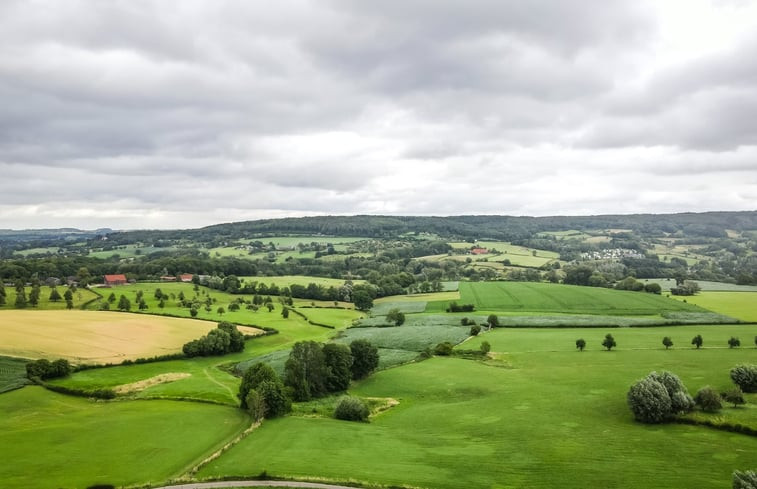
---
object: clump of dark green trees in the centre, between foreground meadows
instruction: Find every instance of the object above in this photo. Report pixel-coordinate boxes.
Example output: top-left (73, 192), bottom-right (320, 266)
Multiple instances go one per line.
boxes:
top-left (238, 340), bottom-right (379, 420)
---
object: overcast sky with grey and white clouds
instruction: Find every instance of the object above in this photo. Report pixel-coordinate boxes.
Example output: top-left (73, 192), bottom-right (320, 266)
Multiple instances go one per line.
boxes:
top-left (0, 0), bottom-right (757, 229)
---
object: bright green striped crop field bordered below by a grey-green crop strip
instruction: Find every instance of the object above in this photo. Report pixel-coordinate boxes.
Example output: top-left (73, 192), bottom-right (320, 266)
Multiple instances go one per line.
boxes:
top-left (442, 282), bottom-right (703, 316)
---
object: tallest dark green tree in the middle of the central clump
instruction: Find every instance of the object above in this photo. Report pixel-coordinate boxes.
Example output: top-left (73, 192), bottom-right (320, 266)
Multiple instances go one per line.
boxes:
top-left (284, 341), bottom-right (327, 402)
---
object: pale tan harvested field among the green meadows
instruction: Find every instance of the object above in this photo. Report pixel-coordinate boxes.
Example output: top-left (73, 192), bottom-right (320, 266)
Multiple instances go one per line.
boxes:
top-left (0, 310), bottom-right (262, 363)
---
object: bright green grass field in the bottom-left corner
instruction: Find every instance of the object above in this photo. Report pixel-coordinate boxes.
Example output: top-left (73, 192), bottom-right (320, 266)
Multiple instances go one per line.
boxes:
top-left (0, 386), bottom-right (249, 489)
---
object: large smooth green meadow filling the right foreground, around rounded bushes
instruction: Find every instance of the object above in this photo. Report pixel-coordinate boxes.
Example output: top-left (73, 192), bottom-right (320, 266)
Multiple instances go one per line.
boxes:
top-left (199, 346), bottom-right (757, 489)
